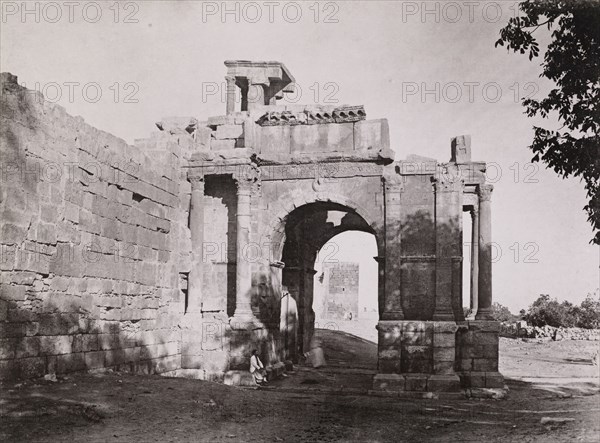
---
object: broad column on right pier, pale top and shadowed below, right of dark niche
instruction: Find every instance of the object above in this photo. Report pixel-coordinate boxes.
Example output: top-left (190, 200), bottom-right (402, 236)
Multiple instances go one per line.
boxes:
top-left (433, 177), bottom-right (463, 321)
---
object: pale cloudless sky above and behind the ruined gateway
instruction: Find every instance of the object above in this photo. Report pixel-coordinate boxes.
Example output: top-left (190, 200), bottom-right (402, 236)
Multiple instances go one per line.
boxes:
top-left (0, 1), bottom-right (600, 312)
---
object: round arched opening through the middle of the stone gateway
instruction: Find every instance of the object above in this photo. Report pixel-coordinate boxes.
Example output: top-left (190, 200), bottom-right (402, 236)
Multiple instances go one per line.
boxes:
top-left (281, 202), bottom-right (381, 365)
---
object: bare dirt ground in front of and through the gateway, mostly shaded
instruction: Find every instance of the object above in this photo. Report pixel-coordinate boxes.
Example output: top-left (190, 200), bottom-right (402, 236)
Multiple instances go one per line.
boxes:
top-left (0, 331), bottom-right (600, 442)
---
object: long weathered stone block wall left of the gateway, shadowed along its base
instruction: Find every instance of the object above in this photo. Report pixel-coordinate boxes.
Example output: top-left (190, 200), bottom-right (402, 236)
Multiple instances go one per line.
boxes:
top-left (0, 74), bottom-right (192, 379)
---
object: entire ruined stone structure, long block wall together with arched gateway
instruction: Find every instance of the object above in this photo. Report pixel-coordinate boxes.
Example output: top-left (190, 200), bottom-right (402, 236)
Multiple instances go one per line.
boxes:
top-left (0, 61), bottom-right (503, 392)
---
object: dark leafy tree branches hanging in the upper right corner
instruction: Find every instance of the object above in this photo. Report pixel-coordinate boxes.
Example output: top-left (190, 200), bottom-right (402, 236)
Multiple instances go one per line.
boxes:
top-left (496, 0), bottom-right (600, 244)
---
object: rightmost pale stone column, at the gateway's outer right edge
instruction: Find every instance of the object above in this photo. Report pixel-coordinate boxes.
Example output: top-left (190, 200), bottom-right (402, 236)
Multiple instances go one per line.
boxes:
top-left (475, 184), bottom-right (494, 320)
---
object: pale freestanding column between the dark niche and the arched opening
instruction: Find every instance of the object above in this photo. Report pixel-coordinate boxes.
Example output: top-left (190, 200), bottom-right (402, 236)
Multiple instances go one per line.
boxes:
top-left (232, 177), bottom-right (257, 325)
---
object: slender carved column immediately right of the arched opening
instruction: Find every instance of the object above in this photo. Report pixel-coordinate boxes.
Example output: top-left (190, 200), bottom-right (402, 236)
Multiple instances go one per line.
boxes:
top-left (379, 176), bottom-right (404, 320)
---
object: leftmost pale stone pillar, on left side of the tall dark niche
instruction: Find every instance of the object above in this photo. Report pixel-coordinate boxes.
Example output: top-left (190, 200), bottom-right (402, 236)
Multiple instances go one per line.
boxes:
top-left (188, 176), bottom-right (204, 312)
